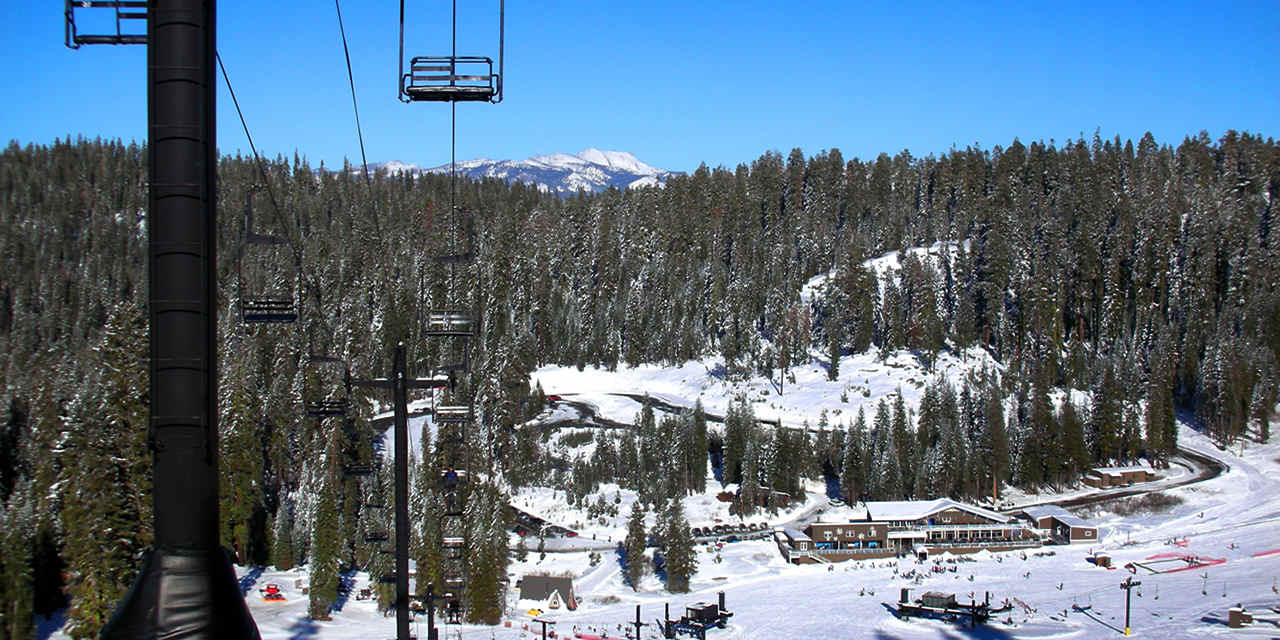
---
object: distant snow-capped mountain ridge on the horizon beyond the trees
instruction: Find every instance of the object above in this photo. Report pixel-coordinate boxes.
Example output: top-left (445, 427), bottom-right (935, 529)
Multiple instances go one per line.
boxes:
top-left (370, 148), bottom-right (677, 195)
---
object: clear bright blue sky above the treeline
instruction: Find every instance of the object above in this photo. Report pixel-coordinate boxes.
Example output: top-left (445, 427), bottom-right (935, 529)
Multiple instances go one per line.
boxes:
top-left (0, 0), bottom-right (1280, 170)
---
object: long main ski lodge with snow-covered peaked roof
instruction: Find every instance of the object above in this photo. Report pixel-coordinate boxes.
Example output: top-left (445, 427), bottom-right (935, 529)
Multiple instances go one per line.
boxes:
top-left (773, 498), bottom-right (1041, 564)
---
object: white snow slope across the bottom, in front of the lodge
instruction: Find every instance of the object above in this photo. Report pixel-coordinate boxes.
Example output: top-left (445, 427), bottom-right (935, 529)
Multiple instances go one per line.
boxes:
top-left (199, 417), bottom-right (1280, 640)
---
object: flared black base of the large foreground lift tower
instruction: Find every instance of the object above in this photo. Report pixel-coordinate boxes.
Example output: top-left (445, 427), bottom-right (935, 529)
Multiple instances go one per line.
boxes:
top-left (99, 549), bottom-right (261, 640)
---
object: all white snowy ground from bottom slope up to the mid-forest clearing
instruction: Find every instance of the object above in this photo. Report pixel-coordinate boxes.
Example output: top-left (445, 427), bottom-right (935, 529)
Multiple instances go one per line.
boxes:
top-left (204, 352), bottom-right (1280, 640)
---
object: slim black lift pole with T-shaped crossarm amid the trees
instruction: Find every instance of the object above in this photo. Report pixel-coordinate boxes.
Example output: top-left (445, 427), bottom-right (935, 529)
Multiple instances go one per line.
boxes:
top-left (352, 342), bottom-right (448, 640)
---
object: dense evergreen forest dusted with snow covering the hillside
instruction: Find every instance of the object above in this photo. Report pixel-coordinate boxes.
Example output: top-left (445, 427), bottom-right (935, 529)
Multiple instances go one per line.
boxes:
top-left (0, 132), bottom-right (1280, 640)
